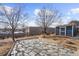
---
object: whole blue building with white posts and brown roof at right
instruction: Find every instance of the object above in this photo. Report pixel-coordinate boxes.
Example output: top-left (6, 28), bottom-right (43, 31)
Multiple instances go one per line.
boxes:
top-left (56, 20), bottom-right (79, 36)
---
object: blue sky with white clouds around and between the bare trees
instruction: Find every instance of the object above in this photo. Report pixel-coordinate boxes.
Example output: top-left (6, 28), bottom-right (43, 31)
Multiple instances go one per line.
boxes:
top-left (0, 3), bottom-right (79, 26)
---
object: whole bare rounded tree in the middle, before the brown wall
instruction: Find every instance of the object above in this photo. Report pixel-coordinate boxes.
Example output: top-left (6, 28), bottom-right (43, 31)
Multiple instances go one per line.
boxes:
top-left (36, 8), bottom-right (61, 34)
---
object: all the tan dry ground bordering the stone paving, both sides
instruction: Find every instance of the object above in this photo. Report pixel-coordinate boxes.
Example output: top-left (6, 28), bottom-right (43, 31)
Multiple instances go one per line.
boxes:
top-left (0, 35), bottom-right (79, 55)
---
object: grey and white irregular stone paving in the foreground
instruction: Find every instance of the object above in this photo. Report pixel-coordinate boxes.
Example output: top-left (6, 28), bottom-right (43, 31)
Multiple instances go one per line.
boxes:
top-left (11, 39), bottom-right (78, 56)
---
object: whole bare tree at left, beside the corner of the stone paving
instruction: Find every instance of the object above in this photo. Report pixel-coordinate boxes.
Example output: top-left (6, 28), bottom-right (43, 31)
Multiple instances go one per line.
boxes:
top-left (0, 6), bottom-right (27, 42)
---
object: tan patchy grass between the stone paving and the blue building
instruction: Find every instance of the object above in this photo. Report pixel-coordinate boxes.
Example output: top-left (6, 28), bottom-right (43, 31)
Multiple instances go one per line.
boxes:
top-left (41, 35), bottom-right (79, 51)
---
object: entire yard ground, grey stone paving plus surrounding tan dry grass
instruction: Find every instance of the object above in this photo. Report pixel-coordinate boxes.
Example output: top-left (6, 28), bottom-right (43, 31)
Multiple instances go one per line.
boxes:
top-left (0, 35), bottom-right (79, 56)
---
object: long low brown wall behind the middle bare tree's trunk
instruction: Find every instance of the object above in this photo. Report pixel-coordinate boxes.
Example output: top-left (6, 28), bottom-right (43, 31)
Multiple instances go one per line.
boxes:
top-left (28, 27), bottom-right (55, 35)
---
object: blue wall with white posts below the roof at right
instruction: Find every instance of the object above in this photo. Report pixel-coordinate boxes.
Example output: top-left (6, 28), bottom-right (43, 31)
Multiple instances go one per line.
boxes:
top-left (56, 26), bottom-right (76, 37)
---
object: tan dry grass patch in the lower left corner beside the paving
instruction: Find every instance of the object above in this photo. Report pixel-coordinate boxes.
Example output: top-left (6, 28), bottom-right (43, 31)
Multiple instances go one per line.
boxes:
top-left (0, 42), bottom-right (12, 56)
